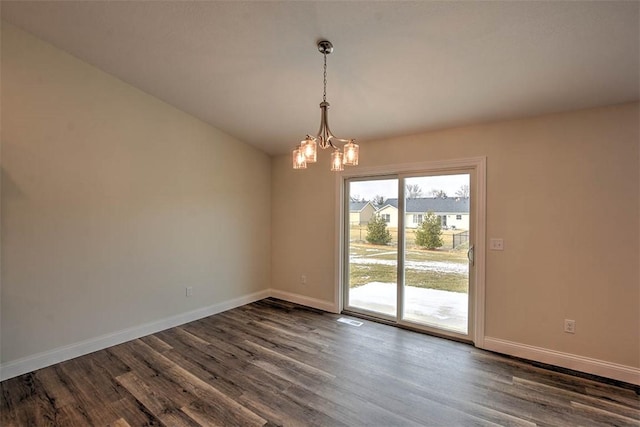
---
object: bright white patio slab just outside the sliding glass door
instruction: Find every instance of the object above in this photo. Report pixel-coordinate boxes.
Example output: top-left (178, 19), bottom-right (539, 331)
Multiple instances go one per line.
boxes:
top-left (349, 282), bottom-right (468, 333)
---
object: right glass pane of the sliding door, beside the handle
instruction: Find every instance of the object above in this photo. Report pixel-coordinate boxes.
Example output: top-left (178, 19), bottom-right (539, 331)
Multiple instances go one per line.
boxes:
top-left (401, 174), bottom-right (471, 335)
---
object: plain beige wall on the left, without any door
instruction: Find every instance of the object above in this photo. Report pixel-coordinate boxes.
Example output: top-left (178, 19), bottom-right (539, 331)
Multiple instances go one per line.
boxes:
top-left (1, 23), bottom-right (271, 362)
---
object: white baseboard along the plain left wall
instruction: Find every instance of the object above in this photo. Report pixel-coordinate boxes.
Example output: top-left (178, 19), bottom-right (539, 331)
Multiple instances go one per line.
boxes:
top-left (0, 290), bottom-right (270, 381)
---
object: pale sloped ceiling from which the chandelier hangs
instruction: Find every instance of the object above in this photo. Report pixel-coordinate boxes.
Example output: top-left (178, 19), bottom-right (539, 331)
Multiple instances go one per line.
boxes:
top-left (1, 1), bottom-right (640, 154)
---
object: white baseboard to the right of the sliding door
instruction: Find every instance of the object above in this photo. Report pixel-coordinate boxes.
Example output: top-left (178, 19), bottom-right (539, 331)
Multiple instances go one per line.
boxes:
top-left (483, 337), bottom-right (640, 385)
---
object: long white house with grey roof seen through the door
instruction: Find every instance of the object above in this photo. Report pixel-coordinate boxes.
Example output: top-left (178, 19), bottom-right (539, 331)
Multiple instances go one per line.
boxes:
top-left (376, 197), bottom-right (469, 230)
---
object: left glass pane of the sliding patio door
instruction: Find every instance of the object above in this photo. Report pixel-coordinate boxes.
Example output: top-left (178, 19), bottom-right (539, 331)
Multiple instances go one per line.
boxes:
top-left (345, 179), bottom-right (398, 320)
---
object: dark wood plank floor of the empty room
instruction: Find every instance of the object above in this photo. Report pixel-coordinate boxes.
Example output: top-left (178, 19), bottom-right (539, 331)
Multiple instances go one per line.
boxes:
top-left (0, 299), bottom-right (640, 426)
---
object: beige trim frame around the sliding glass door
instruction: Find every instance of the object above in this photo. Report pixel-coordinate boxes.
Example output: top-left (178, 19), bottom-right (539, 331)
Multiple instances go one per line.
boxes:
top-left (334, 156), bottom-right (487, 348)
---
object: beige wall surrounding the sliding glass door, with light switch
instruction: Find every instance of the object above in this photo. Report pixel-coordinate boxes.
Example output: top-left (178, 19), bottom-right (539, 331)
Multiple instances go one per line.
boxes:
top-left (272, 104), bottom-right (640, 367)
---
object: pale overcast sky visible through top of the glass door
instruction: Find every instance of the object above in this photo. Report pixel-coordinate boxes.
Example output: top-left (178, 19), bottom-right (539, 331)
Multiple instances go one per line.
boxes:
top-left (349, 174), bottom-right (469, 200)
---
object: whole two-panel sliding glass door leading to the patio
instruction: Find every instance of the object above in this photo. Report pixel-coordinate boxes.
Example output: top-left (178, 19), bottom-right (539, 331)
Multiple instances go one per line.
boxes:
top-left (343, 169), bottom-right (475, 339)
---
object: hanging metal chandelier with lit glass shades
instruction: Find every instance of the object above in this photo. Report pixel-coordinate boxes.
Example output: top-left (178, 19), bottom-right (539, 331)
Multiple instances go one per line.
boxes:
top-left (293, 40), bottom-right (359, 171)
